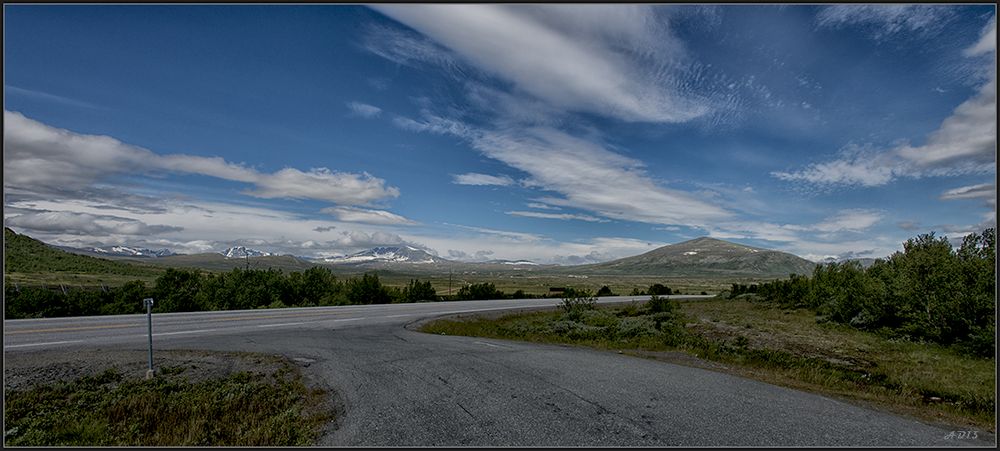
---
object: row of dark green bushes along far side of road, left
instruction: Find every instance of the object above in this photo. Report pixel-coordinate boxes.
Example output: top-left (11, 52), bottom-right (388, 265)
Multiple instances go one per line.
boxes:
top-left (4, 266), bottom-right (596, 319)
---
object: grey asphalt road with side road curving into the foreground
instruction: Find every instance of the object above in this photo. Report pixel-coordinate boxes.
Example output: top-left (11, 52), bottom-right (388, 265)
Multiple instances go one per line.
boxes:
top-left (4, 296), bottom-right (995, 446)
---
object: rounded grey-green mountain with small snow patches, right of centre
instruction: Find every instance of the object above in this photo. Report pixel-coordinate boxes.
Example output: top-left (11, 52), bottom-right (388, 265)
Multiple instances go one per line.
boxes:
top-left (560, 238), bottom-right (816, 277)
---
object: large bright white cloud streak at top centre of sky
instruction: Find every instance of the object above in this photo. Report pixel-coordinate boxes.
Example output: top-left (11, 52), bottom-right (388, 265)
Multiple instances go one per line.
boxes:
top-left (369, 4), bottom-right (710, 122)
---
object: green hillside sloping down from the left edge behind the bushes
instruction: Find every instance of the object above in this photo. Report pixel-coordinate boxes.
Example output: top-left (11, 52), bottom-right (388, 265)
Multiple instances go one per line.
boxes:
top-left (3, 227), bottom-right (163, 278)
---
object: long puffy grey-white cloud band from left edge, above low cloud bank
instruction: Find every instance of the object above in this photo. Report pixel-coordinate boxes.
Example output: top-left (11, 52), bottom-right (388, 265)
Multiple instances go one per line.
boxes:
top-left (4, 110), bottom-right (399, 205)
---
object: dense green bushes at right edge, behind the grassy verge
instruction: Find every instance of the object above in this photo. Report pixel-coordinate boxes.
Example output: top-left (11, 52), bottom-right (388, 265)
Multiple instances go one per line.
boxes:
top-left (752, 228), bottom-right (996, 357)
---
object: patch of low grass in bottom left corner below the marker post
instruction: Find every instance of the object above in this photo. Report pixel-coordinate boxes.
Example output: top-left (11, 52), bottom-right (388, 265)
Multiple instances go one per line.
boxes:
top-left (4, 365), bottom-right (332, 447)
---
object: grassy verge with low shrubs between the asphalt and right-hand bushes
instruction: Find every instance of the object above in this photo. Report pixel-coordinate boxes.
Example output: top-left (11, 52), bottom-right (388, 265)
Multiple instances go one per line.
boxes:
top-left (421, 299), bottom-right (996, 433)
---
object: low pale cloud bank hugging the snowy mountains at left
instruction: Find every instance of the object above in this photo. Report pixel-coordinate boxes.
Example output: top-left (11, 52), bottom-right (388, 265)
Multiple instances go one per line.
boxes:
top-left (4, 199), bottom-right (420, 257)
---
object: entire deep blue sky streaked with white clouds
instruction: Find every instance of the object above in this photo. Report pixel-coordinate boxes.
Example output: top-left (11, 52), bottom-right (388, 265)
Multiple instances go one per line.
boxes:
top-left (4, 4), bottom-right (996, 264)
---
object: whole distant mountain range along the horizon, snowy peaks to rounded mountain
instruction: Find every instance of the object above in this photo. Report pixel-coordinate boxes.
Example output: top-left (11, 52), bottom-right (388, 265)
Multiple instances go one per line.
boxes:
top-left (11, 231), bottom-right (820, 278)
